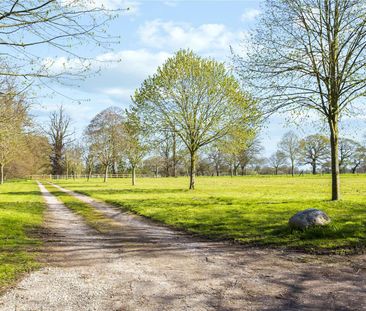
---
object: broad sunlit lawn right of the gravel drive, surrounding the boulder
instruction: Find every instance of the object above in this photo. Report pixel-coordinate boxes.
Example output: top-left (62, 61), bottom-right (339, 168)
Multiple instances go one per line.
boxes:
top-left (53, 175), bottom-right (366, 253)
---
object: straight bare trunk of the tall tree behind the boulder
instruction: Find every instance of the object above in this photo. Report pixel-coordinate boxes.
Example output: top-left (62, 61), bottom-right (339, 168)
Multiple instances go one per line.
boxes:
top-left (329, 119), bottom-right (341, 201)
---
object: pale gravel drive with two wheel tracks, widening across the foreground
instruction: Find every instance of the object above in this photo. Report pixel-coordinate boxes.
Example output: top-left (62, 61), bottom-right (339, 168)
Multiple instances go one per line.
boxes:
top-left (0, 184), bottom-right (366, 311)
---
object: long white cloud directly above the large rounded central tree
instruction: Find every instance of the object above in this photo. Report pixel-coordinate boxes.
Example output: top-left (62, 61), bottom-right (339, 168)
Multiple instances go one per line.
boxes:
top-left (138, 19), bottom-right (244, 56)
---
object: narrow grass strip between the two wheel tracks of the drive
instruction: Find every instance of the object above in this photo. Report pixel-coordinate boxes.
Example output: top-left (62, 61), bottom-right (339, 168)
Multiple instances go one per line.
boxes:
top-left (44, 183), bottom-right (120, 233)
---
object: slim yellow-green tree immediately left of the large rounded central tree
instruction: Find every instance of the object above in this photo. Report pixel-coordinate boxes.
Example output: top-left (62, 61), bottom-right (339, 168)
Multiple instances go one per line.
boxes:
top-left (123, 112), bottom-right (148, 186)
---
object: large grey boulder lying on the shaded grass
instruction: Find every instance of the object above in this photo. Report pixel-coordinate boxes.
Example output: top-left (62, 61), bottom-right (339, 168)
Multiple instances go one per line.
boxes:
top-left (288, 208), bottom-right (330, 230)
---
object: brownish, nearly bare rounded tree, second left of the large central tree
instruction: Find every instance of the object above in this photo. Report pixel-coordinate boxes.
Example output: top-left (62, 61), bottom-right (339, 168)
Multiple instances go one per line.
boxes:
top-left (84, 107), bottom-right (125, 182)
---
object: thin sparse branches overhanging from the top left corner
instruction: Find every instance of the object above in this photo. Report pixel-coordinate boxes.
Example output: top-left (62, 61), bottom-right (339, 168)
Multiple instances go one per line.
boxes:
top-left (0, 0), bottom-right (120, 83)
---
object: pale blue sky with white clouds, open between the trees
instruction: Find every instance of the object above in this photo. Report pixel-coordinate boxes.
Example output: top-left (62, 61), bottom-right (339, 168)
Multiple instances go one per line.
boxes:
top-left (33, 0), bottom-right (365, 156)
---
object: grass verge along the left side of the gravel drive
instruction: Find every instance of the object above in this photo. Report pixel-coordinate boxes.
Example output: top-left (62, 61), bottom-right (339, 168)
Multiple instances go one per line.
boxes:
top-left (0, 181), bottom-right (45, 290)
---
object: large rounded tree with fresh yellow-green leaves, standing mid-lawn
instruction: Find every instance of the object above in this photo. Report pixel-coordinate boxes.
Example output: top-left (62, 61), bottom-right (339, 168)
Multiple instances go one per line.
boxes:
top-left (134, 50), bottom-right (256, 189)
